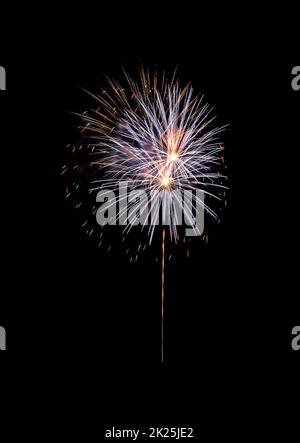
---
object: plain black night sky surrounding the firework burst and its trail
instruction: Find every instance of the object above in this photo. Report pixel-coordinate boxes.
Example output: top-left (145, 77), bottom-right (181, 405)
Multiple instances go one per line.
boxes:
top-left (0, 5), bottom-right (300, 435)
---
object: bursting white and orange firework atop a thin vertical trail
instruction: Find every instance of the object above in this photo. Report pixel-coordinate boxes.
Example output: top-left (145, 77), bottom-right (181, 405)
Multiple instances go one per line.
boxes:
top-left (63, 69), bottom-right (225, 250)
